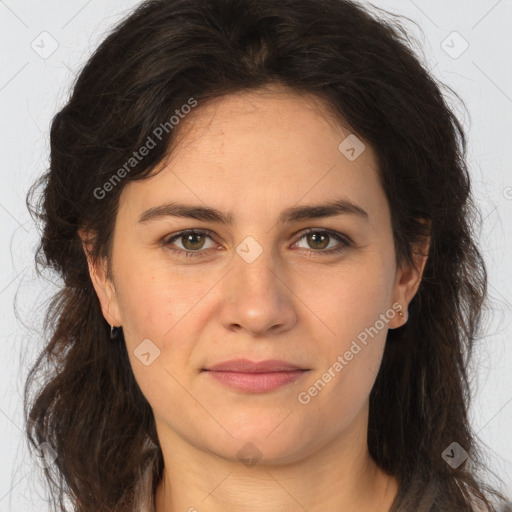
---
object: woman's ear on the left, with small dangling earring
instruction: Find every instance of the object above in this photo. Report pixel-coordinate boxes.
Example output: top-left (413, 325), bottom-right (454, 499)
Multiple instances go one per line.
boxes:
top-left (78, 230), bottom-right (122, 327)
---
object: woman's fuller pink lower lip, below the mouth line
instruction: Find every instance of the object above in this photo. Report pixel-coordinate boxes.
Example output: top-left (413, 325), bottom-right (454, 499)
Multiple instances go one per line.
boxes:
top-left (203, 370), bottom-right (308, 393)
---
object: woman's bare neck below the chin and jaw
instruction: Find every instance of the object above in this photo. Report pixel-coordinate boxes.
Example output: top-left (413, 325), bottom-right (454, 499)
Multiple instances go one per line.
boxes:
top-left (155, 406), bottom-right (398, 512)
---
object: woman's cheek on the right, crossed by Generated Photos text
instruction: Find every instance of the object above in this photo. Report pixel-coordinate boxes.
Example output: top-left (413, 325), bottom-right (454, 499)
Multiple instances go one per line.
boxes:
top-left (302, 258), bottom-right (395, 411)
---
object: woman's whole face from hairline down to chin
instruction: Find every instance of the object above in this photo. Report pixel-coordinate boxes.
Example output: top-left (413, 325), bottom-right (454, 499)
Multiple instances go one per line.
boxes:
top-left (87, 89), bottom-right (420, 463)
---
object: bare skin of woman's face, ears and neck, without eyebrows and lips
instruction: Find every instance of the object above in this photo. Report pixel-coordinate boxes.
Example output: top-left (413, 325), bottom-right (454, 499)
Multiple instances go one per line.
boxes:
top-left (83, 87), bottom-right (428, 512)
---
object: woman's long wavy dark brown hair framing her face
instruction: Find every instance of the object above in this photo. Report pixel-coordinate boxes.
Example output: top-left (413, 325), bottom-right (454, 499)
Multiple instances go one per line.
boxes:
top-left (25, 0), bottom-right (508, 512)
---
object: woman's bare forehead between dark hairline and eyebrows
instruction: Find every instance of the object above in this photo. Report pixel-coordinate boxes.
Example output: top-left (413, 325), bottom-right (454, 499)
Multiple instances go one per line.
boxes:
top-left (117, 88), bottom-right (386, 228)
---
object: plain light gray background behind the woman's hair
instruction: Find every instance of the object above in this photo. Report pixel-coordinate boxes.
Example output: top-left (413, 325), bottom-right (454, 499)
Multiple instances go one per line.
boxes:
top-left (0, 0), bottom-right (512, 512)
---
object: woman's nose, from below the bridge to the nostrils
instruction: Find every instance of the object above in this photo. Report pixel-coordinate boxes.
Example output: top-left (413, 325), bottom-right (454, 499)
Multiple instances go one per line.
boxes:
top-left (220, 240), bottom-right (297, 336)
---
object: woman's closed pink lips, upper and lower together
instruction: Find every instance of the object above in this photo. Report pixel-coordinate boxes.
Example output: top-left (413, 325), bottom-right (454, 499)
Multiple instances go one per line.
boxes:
top-left (206, 359), bottom-right (309, 393)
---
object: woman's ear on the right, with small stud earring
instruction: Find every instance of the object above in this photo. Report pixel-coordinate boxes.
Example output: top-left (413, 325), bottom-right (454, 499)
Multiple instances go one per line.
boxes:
top-left (389, 219), bottom-right (431, 329)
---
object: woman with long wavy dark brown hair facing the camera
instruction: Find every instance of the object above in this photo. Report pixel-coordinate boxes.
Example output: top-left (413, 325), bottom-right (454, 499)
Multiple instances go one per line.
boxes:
top-left (26, 0), bottom-right (512, 512)
